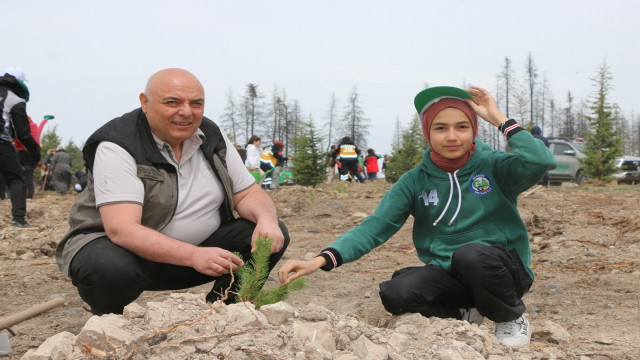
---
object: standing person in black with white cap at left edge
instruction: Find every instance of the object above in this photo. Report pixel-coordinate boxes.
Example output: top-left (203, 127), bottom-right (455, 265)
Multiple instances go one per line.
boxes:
top-left (0, 68), bottom-right (40, 228)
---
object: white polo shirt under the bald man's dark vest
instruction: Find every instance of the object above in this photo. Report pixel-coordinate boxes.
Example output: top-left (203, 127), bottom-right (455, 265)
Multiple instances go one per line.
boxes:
top-left (93, 129), bottom-right (255, 245)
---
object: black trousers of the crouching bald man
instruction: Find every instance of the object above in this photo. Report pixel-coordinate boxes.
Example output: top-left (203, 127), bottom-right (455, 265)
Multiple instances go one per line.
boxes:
top-left (69, 219), bottom-right (289, 315)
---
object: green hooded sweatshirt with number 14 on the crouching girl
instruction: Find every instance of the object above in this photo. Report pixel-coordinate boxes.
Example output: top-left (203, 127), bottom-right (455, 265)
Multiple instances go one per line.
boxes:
top-left (323, 131), bottom-right (556, 279)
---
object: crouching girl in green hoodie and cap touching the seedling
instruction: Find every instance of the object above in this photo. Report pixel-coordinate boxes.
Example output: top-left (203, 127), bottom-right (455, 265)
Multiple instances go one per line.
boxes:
top-left (278, 86), bottom-right (556, 346)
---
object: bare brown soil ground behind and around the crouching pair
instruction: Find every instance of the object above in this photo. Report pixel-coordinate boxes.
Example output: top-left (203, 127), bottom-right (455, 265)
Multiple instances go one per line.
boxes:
top-left (0, 180), bottom-right (640, 359)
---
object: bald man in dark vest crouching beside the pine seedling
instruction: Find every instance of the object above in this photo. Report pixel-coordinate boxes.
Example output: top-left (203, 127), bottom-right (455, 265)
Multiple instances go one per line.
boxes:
top-left (56, 69), bottom-right (289, 314)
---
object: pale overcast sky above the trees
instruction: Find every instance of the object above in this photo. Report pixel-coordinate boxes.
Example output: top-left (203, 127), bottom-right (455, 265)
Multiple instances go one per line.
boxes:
top-left (0, 0), bottom-right (640, 153)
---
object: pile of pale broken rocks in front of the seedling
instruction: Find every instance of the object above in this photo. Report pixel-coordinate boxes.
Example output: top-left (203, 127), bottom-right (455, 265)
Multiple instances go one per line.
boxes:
top-left (22, 293), bottom-right (562, 360)
